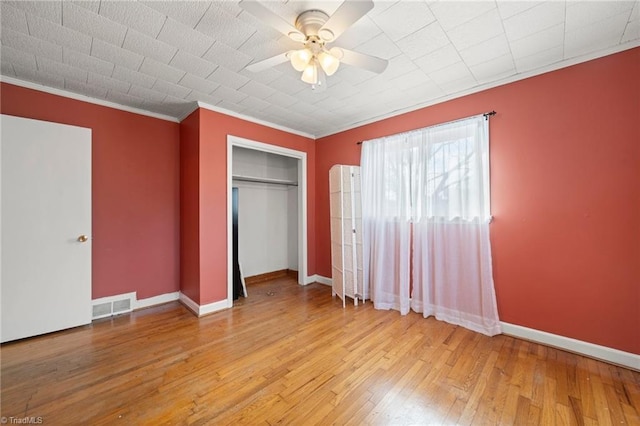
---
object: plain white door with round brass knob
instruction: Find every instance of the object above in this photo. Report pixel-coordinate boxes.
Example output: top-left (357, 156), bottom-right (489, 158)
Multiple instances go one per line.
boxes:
top-left (0, 115), bottom-right (91, 342)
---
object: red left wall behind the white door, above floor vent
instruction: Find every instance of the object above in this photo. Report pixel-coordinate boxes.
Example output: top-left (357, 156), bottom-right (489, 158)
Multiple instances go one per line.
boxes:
top-left (0, 83), bottom-right (179, 299)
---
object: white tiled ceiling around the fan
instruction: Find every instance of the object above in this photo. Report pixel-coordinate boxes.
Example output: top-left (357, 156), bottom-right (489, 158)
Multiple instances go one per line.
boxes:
top-left (0, 0), bottom-right (640, 136)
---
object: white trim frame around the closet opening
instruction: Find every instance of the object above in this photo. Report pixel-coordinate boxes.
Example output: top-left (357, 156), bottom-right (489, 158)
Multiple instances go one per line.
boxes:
top-left (227, 135), bottom-right (312, 306)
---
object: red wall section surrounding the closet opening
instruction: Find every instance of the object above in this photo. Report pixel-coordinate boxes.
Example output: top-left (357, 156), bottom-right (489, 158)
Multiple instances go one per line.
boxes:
top-left (182, 109), bottom-right (316, 305)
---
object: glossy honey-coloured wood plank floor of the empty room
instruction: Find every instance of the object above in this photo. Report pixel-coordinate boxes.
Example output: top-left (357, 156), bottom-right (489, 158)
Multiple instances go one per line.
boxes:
top-left (1, 278), bottom-right (640, 425)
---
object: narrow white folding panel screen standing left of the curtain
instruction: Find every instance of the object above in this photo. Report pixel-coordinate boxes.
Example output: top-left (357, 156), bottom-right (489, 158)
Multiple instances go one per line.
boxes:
top-left (329, 165), bottom-right (369, 307)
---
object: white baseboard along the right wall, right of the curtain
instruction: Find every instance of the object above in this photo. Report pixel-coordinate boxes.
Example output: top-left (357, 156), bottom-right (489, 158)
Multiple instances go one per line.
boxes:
top-left (500, 322), bottom-right (640, 371)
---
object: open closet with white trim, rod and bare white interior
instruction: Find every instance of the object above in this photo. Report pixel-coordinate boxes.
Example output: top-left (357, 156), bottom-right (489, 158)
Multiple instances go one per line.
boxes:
top-left (227, 135), bottom-right (307, 306)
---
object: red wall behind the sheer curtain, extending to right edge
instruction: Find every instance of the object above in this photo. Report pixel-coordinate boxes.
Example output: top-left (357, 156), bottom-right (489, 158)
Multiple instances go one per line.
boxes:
top-left (316, 48), bottom-right (640, 354)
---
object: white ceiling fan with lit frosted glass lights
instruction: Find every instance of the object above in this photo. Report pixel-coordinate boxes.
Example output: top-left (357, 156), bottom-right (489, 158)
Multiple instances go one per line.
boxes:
top-left (239, 0), bottom-right (388, 90)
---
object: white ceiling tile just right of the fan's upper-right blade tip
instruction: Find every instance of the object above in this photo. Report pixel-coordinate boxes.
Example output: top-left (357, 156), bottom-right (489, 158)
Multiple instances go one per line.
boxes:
top-left (372, 1), bottom-right (435, 41)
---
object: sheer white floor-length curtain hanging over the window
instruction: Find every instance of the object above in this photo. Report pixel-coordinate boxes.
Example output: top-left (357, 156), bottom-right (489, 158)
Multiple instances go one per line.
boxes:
top-left (361, 115), bottom-right (501, 335)
